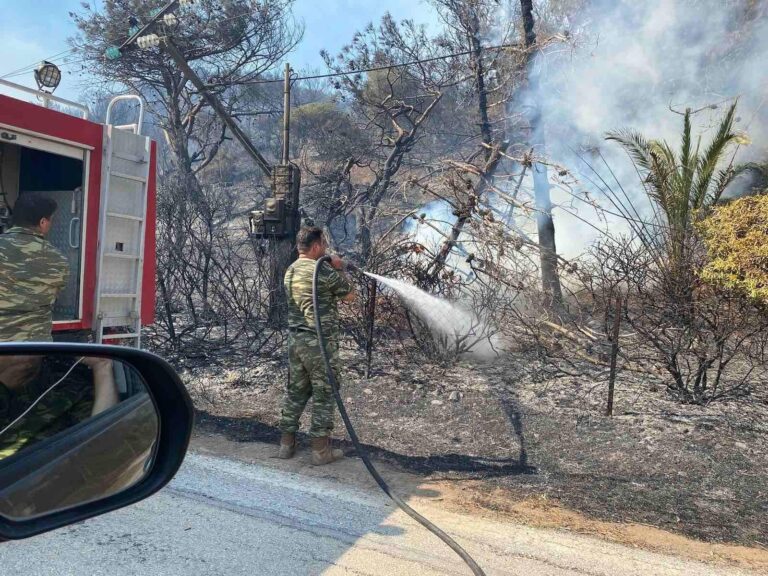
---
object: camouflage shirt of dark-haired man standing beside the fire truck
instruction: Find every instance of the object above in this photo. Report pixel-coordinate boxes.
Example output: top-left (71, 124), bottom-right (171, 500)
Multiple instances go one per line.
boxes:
top-left (0, 226), bottom-right (69, 342)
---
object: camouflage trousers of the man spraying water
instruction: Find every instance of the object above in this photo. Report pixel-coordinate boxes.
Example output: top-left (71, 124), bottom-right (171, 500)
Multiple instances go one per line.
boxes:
top-left (280, 331), bottom-right (340, 438)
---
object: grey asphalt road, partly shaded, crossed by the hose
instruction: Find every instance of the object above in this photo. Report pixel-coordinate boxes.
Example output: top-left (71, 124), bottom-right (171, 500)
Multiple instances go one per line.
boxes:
top-left (0, 453), bottom-right (750, 576)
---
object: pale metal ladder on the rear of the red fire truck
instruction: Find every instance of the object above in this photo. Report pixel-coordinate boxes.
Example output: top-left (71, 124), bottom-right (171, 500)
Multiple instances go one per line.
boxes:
top-left (95, 95), bottom-right (151, 348)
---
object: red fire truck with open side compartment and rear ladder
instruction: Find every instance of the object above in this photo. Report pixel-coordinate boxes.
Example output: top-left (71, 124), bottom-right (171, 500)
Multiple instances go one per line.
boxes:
top-left (0, 80), bottom-right (157, 347)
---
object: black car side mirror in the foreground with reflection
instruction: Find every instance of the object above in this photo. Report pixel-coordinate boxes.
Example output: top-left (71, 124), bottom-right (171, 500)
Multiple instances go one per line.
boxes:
top-left (0, 343), bottom-right (194, 541)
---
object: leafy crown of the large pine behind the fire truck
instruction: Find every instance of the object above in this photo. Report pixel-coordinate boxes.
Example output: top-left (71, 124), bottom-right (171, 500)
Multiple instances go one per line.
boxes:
top-left (70, 0), bottom-right (302, 176)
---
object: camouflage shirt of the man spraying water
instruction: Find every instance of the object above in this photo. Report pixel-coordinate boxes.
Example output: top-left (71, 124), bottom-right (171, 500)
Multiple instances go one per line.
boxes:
top-left (285, 258), bottom-right (352, 337)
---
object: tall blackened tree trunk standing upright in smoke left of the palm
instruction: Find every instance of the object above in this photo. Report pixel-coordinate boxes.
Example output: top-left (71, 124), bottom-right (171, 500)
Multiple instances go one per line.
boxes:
top-left (520, 0), bottom-right (563, 312)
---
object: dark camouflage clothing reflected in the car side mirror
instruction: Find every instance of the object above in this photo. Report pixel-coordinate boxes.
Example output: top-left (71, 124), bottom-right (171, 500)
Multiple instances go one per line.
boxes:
top-left (0, 362), bottom-right (94, 460)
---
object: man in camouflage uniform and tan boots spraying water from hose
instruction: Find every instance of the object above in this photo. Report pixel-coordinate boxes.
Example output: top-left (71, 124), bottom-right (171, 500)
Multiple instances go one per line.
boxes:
top-left (278, 226), bottom-right (355, 466)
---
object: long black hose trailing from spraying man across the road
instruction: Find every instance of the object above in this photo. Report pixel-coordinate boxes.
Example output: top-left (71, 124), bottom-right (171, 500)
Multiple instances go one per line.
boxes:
top-left (312, 256), bottom-right (485, 576)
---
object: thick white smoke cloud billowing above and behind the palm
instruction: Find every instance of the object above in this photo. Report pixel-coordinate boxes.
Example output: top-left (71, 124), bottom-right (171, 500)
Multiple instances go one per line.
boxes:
top-left (528, 0), bottom-right (768, 257)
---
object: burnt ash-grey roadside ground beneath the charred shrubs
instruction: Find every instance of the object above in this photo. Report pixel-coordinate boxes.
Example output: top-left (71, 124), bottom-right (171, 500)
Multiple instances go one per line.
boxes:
top-left (177, 340), bottom-right (768, 548)
